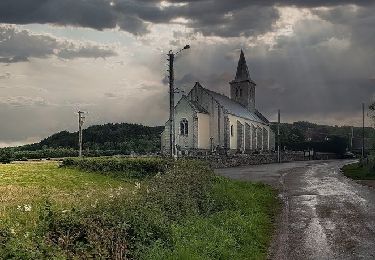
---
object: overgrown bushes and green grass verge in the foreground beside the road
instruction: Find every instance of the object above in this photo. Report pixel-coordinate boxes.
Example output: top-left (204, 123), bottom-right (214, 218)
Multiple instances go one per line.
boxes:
top-left (0, 161), bottom-right (278, 259)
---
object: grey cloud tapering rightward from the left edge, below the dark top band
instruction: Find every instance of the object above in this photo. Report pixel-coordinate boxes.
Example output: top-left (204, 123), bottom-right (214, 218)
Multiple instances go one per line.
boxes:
top-left (0, 26), bottom-right (116, 63)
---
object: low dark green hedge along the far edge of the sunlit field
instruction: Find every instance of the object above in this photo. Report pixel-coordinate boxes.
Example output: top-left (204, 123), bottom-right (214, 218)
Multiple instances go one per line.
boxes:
top-left (62, 158), bottom-right (171, 178)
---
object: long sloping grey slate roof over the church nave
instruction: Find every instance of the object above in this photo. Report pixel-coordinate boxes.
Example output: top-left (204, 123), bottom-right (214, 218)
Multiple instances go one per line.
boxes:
top-left (201, 86), bottom-right (268, 124)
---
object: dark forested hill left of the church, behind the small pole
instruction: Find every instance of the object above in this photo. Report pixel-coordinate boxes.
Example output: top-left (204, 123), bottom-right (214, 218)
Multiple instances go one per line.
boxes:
top-left (18, 123), bottom-right (164, 154)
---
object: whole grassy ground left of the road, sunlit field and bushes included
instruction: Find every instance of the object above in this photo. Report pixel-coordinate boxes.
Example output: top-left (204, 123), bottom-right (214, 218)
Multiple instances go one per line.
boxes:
top-left (0, 159), bottom-right (278, 259)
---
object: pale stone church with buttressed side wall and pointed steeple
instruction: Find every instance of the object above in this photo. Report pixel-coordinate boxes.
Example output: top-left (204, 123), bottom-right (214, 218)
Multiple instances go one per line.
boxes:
top-left (161, 50), bottom-right (275, 155)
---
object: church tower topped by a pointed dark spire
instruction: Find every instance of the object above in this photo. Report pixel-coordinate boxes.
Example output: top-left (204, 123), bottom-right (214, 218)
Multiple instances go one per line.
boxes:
top-left (229, 50), bottom-right (256, 112)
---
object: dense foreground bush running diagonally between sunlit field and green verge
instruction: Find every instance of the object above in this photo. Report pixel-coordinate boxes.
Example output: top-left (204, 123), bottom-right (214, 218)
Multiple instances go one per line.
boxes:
top-left (38, 161), bottom-right (214, 259)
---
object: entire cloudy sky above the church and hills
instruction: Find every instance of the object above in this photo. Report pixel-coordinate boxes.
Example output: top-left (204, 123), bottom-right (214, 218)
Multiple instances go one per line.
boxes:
top-left (0, 0), bottom-right (375, 147)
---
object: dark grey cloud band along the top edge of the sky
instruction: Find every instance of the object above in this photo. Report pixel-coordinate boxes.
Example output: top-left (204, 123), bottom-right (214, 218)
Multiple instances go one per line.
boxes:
top-left (0, 0), bottom-right (371, 37)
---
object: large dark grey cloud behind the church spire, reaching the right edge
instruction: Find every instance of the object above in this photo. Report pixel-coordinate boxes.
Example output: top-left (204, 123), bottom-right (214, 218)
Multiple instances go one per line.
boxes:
top-left (164, 1), bottom-right (375, 124)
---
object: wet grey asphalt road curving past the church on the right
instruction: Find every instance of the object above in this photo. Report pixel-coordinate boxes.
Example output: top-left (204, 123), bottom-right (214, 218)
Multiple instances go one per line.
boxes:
top-left (217, 161), bottom-right (375, 260)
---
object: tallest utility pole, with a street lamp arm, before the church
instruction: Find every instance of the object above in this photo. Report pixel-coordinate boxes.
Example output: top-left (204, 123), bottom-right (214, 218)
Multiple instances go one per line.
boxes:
top-left (167, 45), bottom-right (190, 157)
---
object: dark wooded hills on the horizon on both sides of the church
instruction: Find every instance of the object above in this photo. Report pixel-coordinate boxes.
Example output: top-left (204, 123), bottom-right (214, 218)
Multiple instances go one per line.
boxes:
top-left (0, 122), bottom-right (375, 162)
